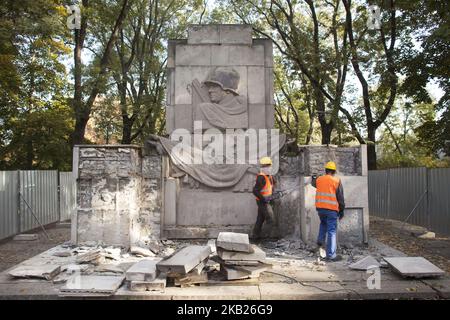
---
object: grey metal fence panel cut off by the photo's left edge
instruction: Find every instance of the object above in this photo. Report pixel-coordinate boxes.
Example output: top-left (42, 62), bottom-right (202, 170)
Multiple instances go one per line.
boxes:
top-left (0, 171), bottom-right (19, 240)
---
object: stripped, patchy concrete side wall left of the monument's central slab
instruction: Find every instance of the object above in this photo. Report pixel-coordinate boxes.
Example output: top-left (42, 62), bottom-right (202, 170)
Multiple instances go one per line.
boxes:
top-left (71, 145), bottom-right (162, 247)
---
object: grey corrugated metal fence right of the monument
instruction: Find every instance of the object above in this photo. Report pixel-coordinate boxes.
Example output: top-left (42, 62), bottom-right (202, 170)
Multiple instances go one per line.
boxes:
top-left (368, 168), bottom-right (450, 235)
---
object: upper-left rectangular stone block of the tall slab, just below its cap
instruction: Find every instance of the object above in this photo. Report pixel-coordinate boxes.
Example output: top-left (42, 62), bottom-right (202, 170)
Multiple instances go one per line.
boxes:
top-left (175, 45), bottom-right (211, 66)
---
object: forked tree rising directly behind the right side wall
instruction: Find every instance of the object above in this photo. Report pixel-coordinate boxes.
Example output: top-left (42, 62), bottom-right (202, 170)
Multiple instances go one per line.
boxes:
top-left (230, 0), bottom-right (348, 144)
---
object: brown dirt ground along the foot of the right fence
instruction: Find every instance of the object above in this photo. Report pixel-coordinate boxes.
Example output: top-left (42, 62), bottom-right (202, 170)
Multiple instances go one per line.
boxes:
top-left (369, 217), bottom-right (450, 272)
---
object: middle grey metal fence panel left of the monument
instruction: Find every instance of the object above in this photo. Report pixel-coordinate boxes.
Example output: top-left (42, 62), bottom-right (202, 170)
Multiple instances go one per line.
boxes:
top-left (19, 170), bottom-right (59, 232)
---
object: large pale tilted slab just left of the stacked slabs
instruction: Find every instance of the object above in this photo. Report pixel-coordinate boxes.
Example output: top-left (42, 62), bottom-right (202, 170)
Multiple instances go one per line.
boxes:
top-left (156, 246), bottom-right (211, 273)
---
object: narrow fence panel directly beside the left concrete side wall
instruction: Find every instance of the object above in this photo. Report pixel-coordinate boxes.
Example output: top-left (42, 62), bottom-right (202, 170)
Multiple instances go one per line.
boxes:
top-left (59, 172), bottom-right (77, 221)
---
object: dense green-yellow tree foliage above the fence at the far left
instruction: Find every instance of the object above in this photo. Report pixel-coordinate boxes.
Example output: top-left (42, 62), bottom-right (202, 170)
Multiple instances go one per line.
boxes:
top-left (0, 0), bottom-right (73, 169)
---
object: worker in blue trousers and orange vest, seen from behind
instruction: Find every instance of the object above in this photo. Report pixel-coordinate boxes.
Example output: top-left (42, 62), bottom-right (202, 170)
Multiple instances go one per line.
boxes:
top-left (311, 161), bottom-right (345, 261)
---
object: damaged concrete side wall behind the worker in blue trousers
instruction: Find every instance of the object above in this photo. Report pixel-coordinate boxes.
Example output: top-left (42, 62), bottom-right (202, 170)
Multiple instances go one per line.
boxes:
top-left (300, 145), bottom-right (369, 245)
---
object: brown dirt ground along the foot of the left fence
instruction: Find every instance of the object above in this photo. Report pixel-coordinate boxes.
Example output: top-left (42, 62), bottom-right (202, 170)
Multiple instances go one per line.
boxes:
top-left (0, 224), bottom-right (70, 271)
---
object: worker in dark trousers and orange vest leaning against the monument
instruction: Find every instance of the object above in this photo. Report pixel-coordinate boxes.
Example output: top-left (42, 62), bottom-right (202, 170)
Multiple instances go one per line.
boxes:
top-left (253, 157), bottom-right (275, 239)
